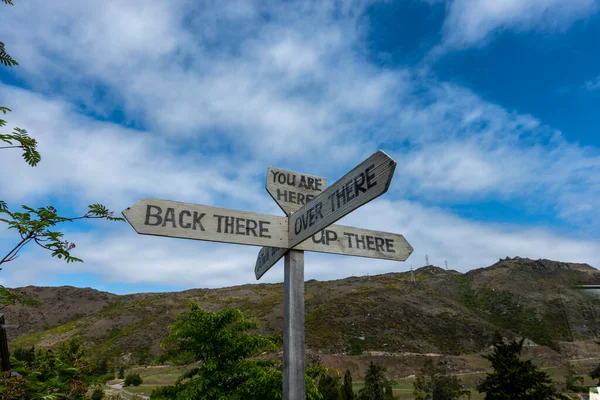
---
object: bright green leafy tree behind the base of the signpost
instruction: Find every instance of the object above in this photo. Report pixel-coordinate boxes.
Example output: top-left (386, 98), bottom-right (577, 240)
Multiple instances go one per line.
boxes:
top-left (151, 304), bottom-right (322, 400)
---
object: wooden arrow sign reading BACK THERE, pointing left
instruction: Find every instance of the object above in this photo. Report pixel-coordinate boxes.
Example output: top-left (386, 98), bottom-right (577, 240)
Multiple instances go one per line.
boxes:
top-left (123, 199), bottom-right (288, 248)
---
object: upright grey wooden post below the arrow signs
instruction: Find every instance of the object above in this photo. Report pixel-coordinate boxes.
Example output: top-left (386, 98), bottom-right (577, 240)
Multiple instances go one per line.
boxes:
top-left (283, 250), bottom-right (306, 400)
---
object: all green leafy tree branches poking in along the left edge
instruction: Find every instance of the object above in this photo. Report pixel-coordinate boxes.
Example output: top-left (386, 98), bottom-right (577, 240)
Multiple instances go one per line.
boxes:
top-left (0, 0), bottom-right (124, 306)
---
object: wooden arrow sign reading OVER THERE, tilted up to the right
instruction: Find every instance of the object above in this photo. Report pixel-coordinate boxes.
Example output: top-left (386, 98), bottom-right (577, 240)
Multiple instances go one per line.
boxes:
top-left (288, 150), bottom-right (396, 248)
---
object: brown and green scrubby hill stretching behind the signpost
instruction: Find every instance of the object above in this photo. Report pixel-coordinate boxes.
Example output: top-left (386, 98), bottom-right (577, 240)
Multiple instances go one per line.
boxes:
top-left (4, 257), bottom-right (600, 370)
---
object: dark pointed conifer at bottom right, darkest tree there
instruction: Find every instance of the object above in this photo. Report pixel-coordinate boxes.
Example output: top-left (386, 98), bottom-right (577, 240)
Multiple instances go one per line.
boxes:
top-left (477, 333), bottom-right (564, 400)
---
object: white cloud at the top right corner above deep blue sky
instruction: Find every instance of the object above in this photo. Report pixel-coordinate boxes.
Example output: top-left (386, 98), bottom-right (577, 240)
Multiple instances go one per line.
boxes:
top-left (443, 0), bottom-right (598, 48)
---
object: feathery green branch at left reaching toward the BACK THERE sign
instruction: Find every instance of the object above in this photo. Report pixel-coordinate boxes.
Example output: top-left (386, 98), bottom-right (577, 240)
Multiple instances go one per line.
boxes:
top-left (0, 205), bottom-right (124, 265)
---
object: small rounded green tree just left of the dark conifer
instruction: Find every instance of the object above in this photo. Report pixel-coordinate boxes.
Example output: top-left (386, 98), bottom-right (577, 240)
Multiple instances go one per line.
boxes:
top-left (413, 360), bottom-right (471, 400)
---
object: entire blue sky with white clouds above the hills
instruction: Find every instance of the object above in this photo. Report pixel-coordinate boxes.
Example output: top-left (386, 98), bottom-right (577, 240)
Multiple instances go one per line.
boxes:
top-left (0, 0), bottom-right (600, 293)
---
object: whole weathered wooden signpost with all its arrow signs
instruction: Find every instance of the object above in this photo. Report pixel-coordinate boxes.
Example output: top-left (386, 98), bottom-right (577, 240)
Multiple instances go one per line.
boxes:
top-left (123, 151), bottom-right (413, 400)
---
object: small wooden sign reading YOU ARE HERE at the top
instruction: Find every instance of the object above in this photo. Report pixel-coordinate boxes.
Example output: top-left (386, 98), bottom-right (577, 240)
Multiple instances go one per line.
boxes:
top-left (266, 167), bottom-right (327, 215)
